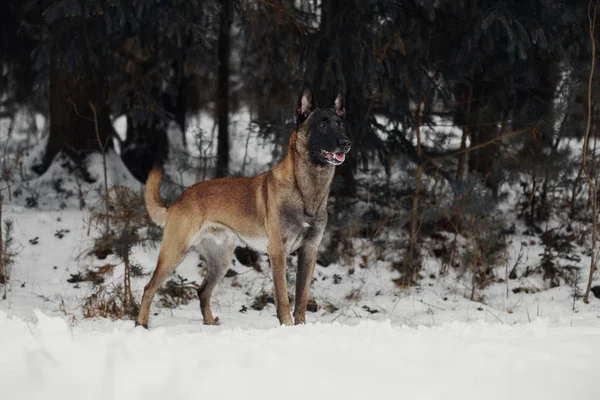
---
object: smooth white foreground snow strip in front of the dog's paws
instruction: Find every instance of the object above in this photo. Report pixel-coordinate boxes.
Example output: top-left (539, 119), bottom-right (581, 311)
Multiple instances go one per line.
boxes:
top-left (0, 312), bottom-right (600, 400)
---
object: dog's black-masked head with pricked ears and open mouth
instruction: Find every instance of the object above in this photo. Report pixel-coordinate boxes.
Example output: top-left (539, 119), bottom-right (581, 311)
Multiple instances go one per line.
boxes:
top-left (296, 85), bottom-right (351, 165)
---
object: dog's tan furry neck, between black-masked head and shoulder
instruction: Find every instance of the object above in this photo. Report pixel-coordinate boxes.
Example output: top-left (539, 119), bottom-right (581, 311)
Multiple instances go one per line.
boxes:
top-left (282, 132), bottom-right (335, 217)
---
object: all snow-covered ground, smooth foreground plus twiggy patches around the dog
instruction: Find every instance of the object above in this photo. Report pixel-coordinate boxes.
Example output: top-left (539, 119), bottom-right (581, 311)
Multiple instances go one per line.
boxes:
top-left (0, 110), bottom-right (600, 400)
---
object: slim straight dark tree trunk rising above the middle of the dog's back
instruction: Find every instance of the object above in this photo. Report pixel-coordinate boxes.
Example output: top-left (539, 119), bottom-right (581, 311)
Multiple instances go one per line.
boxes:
top-left (216, 0), bottom-right (233, 178)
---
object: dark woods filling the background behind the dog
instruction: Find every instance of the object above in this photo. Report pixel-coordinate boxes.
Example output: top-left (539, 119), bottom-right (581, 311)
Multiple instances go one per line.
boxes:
top-left (0, 0), bottom-right (598, 296)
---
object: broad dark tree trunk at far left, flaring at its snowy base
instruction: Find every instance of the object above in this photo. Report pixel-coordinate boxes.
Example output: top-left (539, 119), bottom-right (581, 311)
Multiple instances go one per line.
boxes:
top-left (34, 66), bottom-right (114, 181)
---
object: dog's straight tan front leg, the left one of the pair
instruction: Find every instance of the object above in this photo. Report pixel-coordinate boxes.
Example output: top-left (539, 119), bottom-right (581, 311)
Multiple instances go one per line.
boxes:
top-left (268, 241), bottom-right (293, 325)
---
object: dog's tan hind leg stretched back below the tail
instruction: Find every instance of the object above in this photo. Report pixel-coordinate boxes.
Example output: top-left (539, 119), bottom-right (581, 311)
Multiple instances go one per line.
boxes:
top-left (135, 220), bottom-right (193, 328)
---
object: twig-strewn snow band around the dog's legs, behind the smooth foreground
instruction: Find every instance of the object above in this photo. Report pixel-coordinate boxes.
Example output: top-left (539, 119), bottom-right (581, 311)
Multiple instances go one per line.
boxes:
top-left (0, 204), bottom-right (600, 328)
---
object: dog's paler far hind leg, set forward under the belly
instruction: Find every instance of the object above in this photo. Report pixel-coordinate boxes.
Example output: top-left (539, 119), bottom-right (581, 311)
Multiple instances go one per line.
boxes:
top-left (198, 231), bottom-right (235, 325)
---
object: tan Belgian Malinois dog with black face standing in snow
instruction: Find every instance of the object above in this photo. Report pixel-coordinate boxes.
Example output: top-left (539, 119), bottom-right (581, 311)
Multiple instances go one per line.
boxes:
top-left (136, 85), bottom-right (351, 327)
